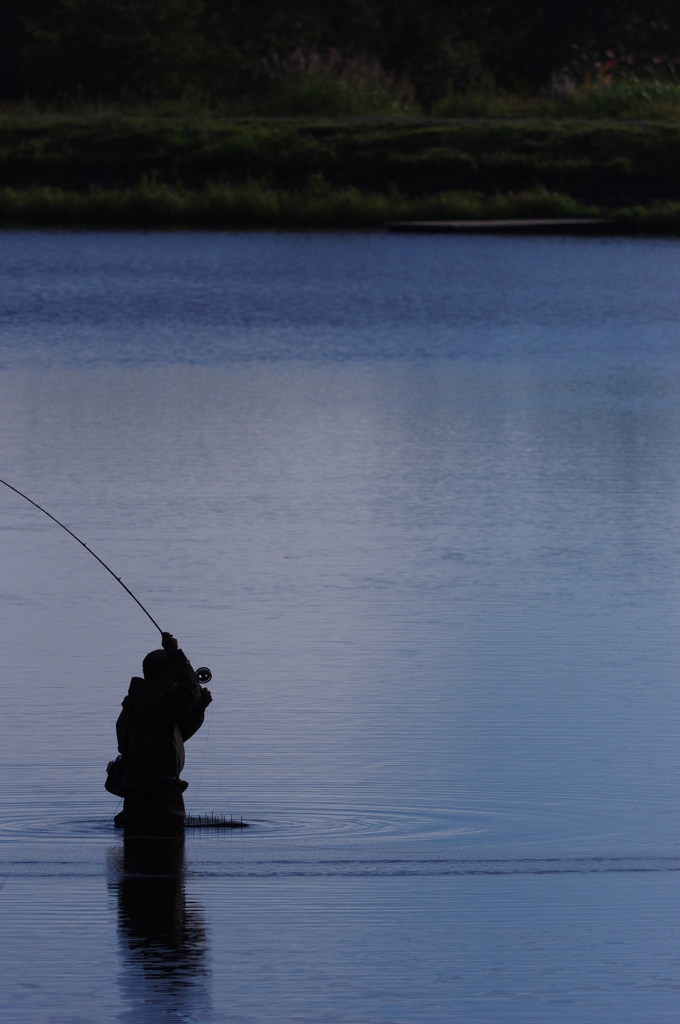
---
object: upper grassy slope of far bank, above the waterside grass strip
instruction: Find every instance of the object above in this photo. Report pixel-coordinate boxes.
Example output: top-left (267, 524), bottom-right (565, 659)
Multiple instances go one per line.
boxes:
top-left (0, 114), bottom-right (680, 208)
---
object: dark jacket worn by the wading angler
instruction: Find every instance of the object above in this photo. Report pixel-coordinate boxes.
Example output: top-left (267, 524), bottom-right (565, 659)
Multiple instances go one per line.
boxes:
top-left (116, 650), bottom-right (205, 796)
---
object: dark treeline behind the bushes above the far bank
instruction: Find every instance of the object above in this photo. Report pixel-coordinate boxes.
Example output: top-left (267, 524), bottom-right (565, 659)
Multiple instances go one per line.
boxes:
top-left (0, 0), bottom-right (680, 112)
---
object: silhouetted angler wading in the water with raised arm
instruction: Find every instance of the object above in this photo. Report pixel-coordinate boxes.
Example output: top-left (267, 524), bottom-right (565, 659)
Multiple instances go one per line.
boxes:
top-left (114, 633), bottom-right (212, 835)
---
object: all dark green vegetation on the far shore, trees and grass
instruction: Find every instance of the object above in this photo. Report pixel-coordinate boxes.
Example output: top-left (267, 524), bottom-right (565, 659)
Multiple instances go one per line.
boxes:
top-left (0, 0), bottom-right (680, 230)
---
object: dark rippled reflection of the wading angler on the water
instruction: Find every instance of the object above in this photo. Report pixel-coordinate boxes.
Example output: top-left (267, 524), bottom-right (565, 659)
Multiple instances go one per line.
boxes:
top-left (118, 837), bottom-right (211, 1024)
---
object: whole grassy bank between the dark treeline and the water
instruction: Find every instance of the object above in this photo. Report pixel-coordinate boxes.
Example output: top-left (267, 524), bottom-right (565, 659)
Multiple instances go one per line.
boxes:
top-left (0, 114), bottom-right (680, 231)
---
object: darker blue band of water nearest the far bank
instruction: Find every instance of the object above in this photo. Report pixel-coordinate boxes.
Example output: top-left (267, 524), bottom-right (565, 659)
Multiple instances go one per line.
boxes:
top-left (0, 231), bottom-right (680, 371)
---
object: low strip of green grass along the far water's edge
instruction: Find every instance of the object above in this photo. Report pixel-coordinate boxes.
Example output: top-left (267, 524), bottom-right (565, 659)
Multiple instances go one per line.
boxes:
top-left (0, 183), bottom-right (680, 233)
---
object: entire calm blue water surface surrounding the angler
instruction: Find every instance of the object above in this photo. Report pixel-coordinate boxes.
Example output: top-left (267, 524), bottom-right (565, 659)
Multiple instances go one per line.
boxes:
top-left (0, 232), bottom-right (680, 1024)
